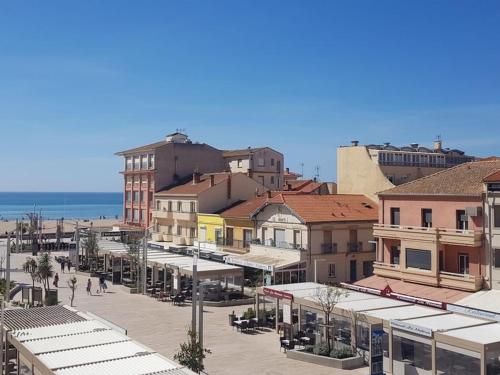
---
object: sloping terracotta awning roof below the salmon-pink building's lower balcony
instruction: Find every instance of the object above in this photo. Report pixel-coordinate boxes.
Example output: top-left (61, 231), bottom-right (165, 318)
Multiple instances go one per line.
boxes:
top-left (354, 275), bottom-right (473, 303)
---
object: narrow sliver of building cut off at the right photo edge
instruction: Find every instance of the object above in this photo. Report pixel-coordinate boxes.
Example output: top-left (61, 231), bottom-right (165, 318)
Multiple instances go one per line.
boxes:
top-left (483, 170), bottom-right (500, 289)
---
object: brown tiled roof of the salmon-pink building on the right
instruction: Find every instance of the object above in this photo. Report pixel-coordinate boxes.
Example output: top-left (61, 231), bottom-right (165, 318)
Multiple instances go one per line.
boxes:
top-left (379, 160), bottom-right (500, 196)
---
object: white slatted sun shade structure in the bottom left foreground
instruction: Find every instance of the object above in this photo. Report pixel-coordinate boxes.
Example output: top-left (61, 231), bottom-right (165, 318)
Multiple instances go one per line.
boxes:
top-left (6, 307), bottom-right (194, 375)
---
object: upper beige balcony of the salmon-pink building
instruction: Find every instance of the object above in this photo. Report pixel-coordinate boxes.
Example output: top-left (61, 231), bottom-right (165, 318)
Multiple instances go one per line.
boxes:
top-left (373, 224), bottom-right (483, 247)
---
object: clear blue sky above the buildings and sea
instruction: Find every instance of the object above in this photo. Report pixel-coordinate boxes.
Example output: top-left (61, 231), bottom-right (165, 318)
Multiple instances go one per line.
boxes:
top-left (0, 0), bottom-right (500, 191)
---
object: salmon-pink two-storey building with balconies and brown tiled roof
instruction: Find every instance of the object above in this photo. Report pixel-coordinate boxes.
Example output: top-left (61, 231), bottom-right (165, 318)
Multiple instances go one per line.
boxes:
top-left (367, 160), bottom-right (500, 297)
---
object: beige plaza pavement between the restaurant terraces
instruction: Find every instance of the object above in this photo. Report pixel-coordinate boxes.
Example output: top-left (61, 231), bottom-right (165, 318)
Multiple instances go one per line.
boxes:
top-left (0, 244), bottom-right (368, 375)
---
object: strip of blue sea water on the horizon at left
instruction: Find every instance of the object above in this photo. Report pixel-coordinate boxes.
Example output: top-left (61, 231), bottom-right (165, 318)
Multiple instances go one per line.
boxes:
top-left (0, 192), bottom-right (123, 220)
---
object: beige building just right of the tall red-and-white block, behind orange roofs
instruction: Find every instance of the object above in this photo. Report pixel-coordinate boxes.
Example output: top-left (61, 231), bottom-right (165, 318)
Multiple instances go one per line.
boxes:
top-left (223, 147), bottom-right (284, 190)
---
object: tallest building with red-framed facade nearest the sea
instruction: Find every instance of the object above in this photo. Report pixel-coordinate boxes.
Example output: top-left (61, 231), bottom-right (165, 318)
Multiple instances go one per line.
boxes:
top-left (116, 132), bottom-right (226, 227)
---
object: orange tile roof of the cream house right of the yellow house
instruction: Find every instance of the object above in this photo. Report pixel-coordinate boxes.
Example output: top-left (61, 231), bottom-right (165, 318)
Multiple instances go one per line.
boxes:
top-left (267, 193), bottom-right (378, 223)
